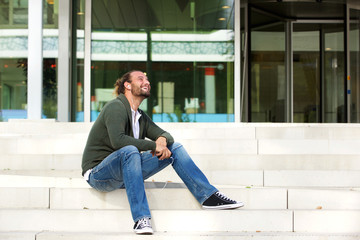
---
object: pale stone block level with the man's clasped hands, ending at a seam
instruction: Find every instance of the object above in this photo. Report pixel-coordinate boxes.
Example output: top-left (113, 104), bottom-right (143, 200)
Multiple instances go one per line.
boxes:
top-left (0, 136), bottom-right (257, 154)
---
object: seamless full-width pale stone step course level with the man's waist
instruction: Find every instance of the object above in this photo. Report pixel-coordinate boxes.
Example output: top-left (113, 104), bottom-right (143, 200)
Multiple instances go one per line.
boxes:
top-left (0, 153), bottom-right (360, 170)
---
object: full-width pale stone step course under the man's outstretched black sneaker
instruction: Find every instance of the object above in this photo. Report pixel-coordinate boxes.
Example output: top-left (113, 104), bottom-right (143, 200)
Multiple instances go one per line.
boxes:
top-left (0, 187), bottom-right (360, 210)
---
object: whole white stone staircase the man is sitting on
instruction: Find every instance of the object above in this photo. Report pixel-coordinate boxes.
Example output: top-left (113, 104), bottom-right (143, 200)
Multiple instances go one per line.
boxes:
top-left (0, 120), bottom-right (360, 240)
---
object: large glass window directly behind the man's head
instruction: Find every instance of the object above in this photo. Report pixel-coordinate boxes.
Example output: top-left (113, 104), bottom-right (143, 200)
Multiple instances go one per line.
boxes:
top-left (91, 0), bottom-right (234, 122)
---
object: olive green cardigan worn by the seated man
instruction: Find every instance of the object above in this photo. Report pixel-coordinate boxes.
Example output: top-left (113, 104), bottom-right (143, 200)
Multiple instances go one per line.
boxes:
top-left (82, 94), bottom-right (174, 175)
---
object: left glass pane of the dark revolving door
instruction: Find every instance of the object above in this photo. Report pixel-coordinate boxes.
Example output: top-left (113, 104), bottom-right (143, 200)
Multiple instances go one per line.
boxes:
top-left (250, 8), bottom-right (286, 122)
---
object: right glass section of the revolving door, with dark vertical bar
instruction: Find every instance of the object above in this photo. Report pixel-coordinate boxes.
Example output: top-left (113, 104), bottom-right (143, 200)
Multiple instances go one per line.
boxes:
top-left (293, 23), bottom-right (346, 123)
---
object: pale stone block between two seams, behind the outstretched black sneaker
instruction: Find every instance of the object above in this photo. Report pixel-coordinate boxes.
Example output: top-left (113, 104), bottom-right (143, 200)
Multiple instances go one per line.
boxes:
top-left (50, 188), bottom-right (287, 210)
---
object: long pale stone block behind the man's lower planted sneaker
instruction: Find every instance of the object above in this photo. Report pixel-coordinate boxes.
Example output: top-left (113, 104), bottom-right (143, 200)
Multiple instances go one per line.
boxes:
top-left (0, 210), bottom-right (293, 232)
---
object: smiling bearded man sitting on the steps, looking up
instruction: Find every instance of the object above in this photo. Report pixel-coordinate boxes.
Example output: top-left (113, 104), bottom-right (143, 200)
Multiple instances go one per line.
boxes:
top-left (82, 71), bottom-right (243, 234)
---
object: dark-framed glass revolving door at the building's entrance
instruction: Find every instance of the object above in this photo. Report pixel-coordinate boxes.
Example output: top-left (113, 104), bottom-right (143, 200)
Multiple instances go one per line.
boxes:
top-left (242, 0), bottom-right (360, 123)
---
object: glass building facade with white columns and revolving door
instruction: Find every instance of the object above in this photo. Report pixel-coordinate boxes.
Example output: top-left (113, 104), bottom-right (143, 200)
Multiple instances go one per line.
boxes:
top-left (0, 0), bottom-right (360, 123)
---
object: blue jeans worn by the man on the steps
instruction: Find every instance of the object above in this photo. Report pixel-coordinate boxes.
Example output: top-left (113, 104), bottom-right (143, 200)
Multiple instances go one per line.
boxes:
top-left (88, 143), bottom-right (217, 222)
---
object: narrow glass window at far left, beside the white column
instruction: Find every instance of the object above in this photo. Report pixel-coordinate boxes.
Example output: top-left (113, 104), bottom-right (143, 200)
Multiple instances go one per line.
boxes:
top-left (0, 0), bottom-right (28, 121)
